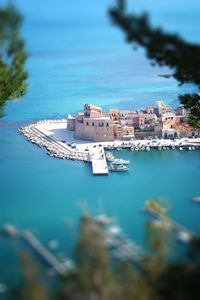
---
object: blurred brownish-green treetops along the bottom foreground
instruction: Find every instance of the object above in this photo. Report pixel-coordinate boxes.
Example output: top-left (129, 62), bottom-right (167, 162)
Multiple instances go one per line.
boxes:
top-left (15, 199), bottom-right (200, 300)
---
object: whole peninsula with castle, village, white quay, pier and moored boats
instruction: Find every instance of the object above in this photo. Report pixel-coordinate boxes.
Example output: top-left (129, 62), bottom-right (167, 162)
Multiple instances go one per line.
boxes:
top-left (18, 100), bottom-right (200, 175)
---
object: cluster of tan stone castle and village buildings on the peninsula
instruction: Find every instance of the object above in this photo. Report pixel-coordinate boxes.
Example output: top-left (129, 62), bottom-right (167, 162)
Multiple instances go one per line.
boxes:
top-left (67, 100), bottom-right (200, 142)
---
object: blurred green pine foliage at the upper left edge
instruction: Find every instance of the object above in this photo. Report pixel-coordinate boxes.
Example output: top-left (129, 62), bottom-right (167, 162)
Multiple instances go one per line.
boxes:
top-left (0, 4), bottom-right (27, 117)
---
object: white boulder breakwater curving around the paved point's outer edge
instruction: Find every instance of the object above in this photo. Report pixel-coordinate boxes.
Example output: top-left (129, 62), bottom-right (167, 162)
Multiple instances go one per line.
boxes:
top-left (18, 119), bottom-right (90, 162)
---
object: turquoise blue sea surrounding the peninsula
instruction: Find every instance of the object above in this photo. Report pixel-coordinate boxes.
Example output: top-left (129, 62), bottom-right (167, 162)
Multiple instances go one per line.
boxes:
top-left (0, 0), bottom-right (200, 290)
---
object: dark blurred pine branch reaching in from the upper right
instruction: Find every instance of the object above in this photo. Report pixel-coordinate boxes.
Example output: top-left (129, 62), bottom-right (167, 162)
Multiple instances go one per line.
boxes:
top-left (109, 0), bottom-right (200, 128)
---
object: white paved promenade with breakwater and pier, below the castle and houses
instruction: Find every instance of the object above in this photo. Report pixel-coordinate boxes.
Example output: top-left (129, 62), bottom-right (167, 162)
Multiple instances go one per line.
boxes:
top-left (18, 119), bottom-right (200, 175)
